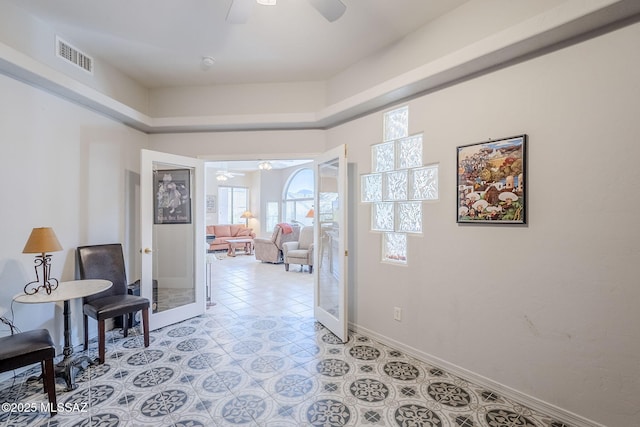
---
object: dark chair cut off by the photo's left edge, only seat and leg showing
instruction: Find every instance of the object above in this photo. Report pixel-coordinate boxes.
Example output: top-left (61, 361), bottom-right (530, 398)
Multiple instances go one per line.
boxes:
top-left (0, 329), bottom-right (58, 416)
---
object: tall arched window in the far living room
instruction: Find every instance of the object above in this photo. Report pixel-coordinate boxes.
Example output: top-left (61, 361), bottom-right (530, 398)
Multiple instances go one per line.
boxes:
top-left (282, 168), bottom-right (314, 225)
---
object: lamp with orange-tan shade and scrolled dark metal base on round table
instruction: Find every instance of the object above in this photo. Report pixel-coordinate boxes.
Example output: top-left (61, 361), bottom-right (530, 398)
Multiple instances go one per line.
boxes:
top-left (22, 227), bottom-right (62, 295)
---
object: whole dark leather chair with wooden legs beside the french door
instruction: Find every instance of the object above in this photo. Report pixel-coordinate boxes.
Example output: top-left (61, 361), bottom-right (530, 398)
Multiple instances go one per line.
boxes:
top-left (77, 243), bottom-right (149, 363)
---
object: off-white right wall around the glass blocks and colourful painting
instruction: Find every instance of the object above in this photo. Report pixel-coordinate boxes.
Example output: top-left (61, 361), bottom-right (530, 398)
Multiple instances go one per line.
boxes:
top-left (328, 20), bottom-right (640, 426)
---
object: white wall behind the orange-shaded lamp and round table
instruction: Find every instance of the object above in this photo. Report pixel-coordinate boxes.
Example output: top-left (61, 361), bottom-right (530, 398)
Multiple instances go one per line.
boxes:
top-left (0, 75), bottom-right (147, 354)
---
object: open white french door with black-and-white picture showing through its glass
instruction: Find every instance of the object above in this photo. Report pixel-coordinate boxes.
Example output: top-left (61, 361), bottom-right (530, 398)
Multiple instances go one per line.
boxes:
top-left (140, 150), bottom-right (206, 330)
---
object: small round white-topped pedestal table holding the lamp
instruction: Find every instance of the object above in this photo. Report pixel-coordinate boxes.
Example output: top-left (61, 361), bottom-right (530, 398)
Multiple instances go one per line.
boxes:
top-left (13, 280), bottom-right (113, 391)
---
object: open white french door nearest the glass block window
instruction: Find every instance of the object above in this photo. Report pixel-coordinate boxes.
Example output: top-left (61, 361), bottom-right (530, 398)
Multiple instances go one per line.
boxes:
top-left (314, 145), bottom-right (349, 342)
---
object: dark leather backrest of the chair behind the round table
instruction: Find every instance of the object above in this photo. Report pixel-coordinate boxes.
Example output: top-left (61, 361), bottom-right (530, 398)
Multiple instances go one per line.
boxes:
top-left (76, 243), bottom-right (127, 302)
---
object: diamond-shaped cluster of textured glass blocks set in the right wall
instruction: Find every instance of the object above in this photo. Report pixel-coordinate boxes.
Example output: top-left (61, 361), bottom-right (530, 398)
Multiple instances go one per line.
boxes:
top-left (360, 106), bottom-right (438, 264)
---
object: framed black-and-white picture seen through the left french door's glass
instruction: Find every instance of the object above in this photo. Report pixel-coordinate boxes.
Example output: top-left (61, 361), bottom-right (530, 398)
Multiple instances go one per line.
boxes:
top-left (153, 169), bottom-right (191, 224)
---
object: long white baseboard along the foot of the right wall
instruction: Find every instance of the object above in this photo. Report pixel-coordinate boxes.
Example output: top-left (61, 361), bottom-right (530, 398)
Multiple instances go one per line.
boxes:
top-left (349, 323), bottom-right (606, 427)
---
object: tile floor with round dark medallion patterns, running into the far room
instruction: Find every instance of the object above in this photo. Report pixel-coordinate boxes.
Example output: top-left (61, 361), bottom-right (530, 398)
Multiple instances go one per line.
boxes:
top-left (0, 256), bottom-right (565, 427)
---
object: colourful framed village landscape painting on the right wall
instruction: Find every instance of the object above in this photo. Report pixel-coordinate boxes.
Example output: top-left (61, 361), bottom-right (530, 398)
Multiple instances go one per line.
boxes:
top-left (456, 135), bottom-right (527, 224)
